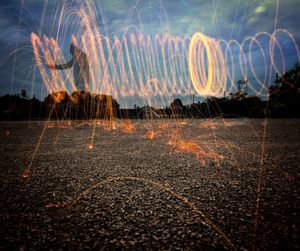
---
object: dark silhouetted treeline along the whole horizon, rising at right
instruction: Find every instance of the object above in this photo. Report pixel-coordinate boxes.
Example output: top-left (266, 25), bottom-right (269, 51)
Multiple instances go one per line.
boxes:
top-left (0, 64), bottom-right (300, 120)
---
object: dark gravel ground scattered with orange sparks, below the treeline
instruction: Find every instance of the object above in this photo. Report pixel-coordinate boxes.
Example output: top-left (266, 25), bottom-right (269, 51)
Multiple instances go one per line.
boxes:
top-left (0, 119), bottom-right (300, 250)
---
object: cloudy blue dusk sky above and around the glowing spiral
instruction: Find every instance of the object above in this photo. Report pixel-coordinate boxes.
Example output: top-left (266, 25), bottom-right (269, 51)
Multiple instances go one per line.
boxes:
top-left (0, 0), bottom-right (300, 104)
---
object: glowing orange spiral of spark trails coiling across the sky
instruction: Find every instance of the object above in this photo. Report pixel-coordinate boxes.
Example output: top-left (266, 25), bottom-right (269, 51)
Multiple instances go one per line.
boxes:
top-left (31, 27), bottom-right (300, 101)
